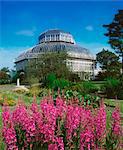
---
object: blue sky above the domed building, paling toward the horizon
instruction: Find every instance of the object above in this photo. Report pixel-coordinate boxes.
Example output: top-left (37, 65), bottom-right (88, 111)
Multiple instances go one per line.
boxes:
top-left (0, 0), bottom-right (123, 69)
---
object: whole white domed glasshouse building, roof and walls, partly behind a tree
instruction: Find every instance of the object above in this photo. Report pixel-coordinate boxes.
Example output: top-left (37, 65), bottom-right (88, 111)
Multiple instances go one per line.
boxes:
top-left (15, 30), bottom-right (95, 80)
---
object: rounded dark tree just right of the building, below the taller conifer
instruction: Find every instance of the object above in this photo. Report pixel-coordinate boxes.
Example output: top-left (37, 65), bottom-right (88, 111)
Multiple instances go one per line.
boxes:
top-left (96, 49), bottom-right (121, 78)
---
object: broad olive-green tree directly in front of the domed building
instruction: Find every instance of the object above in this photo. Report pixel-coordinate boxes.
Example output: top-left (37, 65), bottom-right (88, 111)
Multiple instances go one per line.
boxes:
top-left (26, 52), bottom-right (70, 84)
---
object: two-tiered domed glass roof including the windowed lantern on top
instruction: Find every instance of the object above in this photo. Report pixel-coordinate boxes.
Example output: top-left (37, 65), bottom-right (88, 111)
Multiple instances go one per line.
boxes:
top-left (15, 29), bottom-right (94, 63)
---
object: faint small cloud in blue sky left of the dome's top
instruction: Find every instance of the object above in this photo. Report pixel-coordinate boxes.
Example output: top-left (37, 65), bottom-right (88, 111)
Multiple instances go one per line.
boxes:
top-left (16, 27), bottom-right (36, 36)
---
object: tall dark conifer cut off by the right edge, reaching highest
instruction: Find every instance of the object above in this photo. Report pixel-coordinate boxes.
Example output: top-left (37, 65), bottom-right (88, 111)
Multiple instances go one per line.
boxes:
top-left (103, 10), bottom-right (123, 73)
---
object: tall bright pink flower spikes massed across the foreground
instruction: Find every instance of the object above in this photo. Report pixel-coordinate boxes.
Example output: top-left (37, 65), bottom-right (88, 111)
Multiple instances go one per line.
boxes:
top-left (2, 95), bottom-right (121, 150)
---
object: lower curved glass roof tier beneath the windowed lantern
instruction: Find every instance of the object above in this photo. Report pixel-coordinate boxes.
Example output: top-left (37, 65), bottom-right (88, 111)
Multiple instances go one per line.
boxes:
top-left (15, 42), bottom-right (94, 62)
